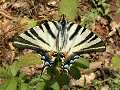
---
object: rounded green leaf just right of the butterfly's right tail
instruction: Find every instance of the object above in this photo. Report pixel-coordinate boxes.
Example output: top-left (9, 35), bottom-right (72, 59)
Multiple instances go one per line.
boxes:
top-left (73, 58), bottom-right (90, 69)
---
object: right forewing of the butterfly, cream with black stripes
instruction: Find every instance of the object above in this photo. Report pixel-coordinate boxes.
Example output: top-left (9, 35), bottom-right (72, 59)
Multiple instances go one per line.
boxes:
top-left (63, 23), bottom-right (105, 55)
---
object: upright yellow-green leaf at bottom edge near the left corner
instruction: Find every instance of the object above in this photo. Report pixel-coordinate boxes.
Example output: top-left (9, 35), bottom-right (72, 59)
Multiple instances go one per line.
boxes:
top-left (6, 78), bottom-right (17, 90)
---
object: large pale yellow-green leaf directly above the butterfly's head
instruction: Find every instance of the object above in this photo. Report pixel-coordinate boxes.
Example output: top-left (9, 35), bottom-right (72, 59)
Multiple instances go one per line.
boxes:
top-left (59, 0), bottom-right (79, 20)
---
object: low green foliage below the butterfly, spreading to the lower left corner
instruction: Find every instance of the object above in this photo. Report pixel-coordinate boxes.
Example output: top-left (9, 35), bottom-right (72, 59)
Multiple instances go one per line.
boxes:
top-left (0, 53), bottom-right (89, 90)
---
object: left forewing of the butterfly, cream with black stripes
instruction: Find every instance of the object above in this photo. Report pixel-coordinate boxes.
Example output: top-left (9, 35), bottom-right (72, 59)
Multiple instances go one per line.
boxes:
top-left (13, 21), bottom-right (58, 54)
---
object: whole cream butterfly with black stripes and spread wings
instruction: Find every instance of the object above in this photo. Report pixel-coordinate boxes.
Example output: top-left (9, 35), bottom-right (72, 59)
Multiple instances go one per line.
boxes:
top-left (13, 17), bottom-right (105, 68)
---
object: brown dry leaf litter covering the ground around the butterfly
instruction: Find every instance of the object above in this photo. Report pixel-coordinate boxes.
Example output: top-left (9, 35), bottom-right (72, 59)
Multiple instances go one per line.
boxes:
top-left (0, 0), bottom-right (120, 90)
